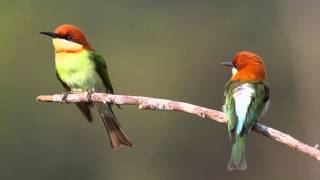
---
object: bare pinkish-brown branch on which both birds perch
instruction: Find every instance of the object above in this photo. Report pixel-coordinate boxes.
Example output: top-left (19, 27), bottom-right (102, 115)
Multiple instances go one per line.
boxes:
top-left (37, 93), bottom-right (320, 161)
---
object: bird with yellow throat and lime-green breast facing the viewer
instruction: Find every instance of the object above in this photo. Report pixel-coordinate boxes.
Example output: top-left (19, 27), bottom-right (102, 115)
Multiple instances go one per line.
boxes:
top-left (40, 24), bottom-right (134, 149)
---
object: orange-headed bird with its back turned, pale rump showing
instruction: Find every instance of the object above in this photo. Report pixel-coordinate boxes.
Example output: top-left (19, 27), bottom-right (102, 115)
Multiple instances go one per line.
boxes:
top-left (221, 51), bottom-right (270, 171)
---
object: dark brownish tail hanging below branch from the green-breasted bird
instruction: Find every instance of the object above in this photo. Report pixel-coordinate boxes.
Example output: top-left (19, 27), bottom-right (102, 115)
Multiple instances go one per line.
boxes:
top-left (98, 104), bottom-right (134, 149)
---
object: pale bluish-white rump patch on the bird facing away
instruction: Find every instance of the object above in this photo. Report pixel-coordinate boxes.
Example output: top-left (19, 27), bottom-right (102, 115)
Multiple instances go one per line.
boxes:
top-left (233, 83), bottom-right (255, 133)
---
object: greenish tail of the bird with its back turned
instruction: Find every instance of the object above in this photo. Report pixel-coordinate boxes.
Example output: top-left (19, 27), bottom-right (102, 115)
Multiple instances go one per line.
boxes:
top-left (227, 134), bottom-right (247, 171)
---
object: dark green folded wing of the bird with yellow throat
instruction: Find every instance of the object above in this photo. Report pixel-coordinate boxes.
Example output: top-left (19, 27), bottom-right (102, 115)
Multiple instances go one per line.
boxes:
top-left (90, 52), bottom-right (113, 94)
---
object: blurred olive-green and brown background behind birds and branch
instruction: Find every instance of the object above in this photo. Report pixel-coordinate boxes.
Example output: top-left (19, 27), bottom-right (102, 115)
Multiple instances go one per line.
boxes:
top-left (0, 0), bottom-right (320, 180)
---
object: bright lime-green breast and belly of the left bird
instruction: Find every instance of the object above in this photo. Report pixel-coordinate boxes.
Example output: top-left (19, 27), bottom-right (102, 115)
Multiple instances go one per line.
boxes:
top-left (56, 53), bottom-right (96, 92)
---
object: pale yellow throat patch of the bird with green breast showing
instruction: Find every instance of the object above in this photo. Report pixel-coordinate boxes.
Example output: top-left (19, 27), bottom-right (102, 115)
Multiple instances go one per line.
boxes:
top-left (52, 38), bottom-right (83, 52)
